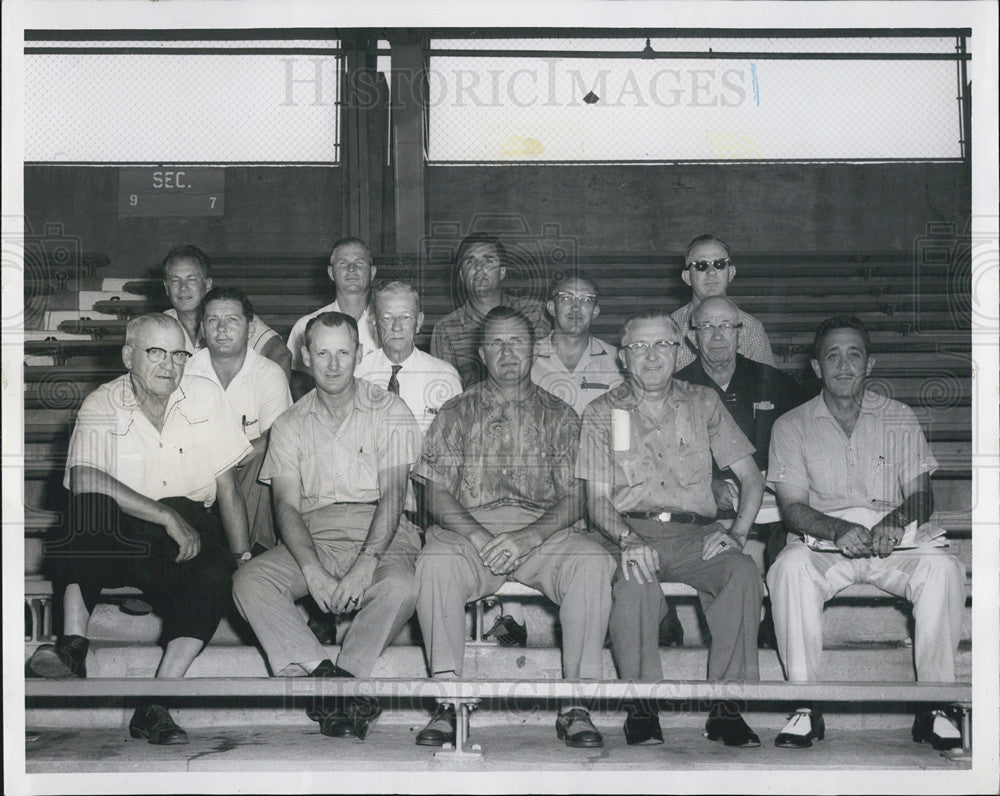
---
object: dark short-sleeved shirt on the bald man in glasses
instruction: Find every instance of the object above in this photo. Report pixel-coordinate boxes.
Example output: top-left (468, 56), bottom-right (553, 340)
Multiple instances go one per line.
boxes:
top-left (674, 354), bottom-right (805, 475)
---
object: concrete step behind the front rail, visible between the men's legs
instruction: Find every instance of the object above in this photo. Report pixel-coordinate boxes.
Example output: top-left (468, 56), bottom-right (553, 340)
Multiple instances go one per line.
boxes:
top-left (26, 642), bottom-right (972, 730)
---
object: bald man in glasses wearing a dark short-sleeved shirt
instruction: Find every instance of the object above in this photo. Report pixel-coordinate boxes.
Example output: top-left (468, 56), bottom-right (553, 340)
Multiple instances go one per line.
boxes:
top-left (676, 296), bottom-right (812, 648)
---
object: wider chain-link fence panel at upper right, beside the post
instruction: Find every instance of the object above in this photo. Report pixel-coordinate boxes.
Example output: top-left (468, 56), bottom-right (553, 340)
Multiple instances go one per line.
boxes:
top-left (428, 37), bottom-right (962, 163)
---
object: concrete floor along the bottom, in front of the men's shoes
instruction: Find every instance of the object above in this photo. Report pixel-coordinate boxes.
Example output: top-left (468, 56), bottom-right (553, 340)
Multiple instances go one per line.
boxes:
top-left (26, 722), bottom-right (970, 774)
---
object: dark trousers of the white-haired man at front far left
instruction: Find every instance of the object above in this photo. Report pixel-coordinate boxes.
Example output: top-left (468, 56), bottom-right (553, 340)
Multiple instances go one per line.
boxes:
top-left (45, 493), bottom-right (234, 645)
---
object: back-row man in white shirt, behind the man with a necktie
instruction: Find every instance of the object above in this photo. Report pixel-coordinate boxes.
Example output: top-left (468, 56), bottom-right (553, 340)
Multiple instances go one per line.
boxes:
top-left (288, 238), bottom-right (378, 401)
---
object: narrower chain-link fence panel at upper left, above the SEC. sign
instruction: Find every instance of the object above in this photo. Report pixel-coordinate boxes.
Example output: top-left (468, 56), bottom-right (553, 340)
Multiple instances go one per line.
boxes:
top-left (24, 40), bottom-right (343, 164)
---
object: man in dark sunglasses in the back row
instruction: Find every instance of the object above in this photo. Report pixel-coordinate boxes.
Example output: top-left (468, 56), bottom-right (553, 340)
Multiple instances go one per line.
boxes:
top-left (671, 235), bottom-right (775, 368)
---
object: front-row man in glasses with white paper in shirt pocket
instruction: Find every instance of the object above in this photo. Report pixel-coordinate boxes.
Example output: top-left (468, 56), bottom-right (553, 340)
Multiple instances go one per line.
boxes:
top-left (576, 310), bottom-right (764, 746)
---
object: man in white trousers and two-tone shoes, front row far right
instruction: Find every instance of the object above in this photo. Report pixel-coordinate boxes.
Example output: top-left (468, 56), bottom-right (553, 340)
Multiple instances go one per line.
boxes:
top-left (767, 315), bottom-right (965, 749)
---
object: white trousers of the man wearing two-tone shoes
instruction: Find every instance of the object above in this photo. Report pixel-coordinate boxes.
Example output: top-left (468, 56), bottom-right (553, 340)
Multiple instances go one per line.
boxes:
top-left (767, 539), bottom-right (965, 683)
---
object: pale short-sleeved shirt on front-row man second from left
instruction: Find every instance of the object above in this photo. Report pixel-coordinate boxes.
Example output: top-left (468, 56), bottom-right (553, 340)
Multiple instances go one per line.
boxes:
top-left (260, 379), bottom-right (420, 539)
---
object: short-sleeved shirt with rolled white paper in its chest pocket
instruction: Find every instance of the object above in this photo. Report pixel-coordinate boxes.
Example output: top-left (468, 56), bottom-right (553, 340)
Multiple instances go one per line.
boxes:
top-left (576, 379), bottom-right (753, 517)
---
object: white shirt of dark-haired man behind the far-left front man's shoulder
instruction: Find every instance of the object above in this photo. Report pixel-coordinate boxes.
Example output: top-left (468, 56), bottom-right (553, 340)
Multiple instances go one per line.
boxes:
top-left (184, 348), bottom-right (292, 442)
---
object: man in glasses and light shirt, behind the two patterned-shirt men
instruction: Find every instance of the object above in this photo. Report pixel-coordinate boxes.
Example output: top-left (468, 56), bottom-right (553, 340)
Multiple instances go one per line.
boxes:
top-left (531, 271), bottom-right (624, 414)
